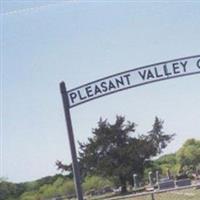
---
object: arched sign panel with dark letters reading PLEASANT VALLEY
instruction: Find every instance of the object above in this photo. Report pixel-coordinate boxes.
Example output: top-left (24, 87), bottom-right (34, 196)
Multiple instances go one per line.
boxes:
top-left (68, 56), bottom-right (200, 107)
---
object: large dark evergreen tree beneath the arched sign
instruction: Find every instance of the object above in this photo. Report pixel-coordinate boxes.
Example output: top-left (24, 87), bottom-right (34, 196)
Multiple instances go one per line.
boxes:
top-left (79, 116), bottom-right (174, 193)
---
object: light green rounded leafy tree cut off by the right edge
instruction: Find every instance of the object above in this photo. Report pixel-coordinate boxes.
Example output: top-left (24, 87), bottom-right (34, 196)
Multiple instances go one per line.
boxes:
top-left (177, 139), bottom-right (200, 171)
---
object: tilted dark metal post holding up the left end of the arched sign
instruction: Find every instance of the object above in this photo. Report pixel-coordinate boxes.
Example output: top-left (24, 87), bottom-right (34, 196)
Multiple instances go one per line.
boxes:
top-left (60, 82), bottom-right (83, 200)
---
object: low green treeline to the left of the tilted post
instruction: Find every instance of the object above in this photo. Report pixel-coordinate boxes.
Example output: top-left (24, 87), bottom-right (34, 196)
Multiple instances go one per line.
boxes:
top-left (0, 174), bottom-right (74, 200)
